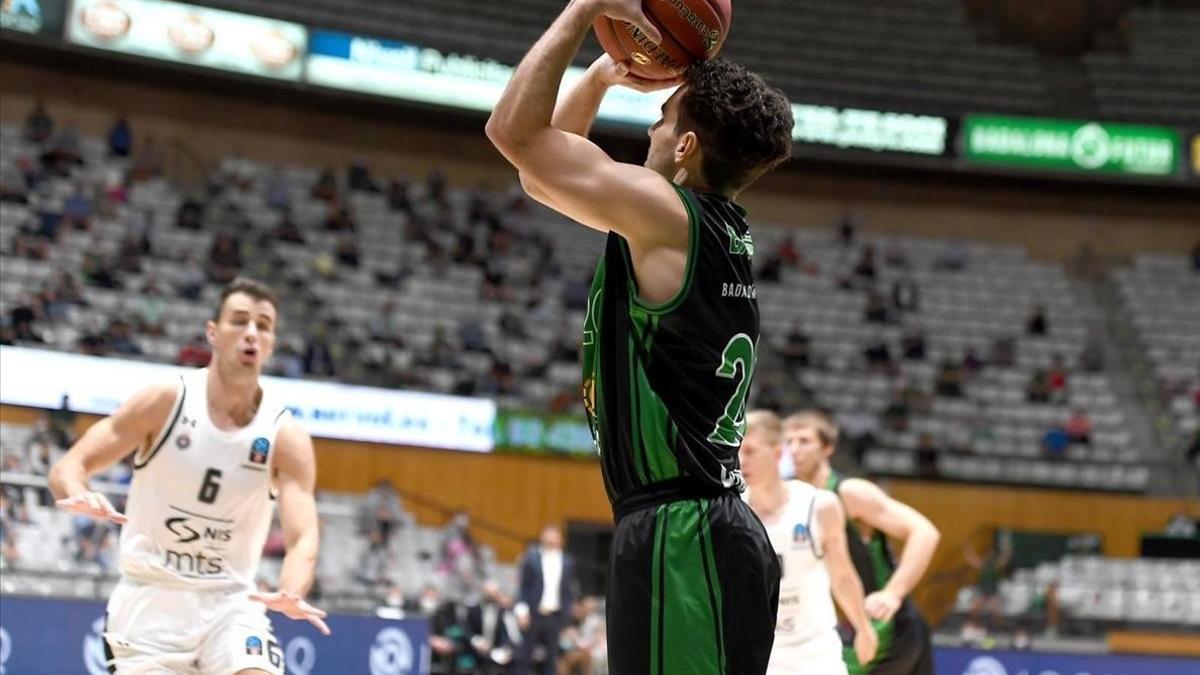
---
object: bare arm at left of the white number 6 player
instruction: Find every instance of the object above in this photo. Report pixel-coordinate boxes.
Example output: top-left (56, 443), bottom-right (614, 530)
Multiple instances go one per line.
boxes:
top-left (49, 381), bottom-right (180, 522)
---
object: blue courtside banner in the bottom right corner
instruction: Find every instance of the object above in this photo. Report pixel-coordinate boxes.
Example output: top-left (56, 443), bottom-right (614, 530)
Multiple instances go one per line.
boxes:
top-left (934, 649), bottom-right (1200, 675)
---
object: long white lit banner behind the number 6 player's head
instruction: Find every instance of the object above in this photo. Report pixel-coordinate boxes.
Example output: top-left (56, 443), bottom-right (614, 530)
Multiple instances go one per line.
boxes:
top-left (0, 347), bottom-right (496, 453)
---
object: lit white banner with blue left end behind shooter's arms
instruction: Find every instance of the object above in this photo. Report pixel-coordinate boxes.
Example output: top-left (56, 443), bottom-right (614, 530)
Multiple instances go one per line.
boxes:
top-left (305, 29), bottom-right (671, 125)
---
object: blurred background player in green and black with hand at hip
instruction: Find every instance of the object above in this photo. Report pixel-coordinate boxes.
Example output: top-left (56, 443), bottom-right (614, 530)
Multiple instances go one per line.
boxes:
top-left (784, 411), bottom-right (941, 675)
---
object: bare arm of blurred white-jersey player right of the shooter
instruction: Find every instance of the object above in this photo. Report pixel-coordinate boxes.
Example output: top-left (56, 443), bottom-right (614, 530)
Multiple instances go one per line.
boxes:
top-left (814, 490), bottom-right (880, 664)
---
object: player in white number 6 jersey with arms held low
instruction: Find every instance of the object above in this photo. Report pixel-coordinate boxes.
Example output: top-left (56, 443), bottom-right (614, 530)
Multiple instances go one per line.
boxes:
top-left (50, 279), bottom-right (329, 675)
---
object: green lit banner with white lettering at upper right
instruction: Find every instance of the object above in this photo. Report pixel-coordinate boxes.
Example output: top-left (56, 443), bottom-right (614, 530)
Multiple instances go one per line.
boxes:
top-left (962, 115), bottom-right (1182, 175)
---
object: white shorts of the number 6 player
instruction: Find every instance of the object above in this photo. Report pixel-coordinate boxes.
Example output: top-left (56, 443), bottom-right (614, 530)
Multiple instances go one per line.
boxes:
top-left (104, 579), bottom-right (283, 675)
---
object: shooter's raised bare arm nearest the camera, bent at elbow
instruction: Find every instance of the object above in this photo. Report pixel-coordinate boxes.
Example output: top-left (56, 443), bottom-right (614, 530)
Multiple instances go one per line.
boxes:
top-left (487, 0), bottom-right (698, 241)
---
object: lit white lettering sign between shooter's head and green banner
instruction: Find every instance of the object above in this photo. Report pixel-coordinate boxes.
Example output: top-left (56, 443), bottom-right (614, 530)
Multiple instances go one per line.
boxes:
top-left (792, 103), bottom-right (950, 156)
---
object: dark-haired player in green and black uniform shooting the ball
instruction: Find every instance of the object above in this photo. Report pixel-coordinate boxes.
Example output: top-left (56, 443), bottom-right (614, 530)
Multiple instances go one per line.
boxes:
top-left (487, 0), bottom-right (792, 675)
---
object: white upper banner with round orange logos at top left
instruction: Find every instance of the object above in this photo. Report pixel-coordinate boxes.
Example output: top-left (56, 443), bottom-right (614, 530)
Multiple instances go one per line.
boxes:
top-left (66, 0), bottom-right (307, 80)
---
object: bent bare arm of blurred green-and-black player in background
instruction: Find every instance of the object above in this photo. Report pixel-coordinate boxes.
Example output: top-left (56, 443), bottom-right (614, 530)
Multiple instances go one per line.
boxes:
top-left (840, 479), bottom-right (941, 620)
